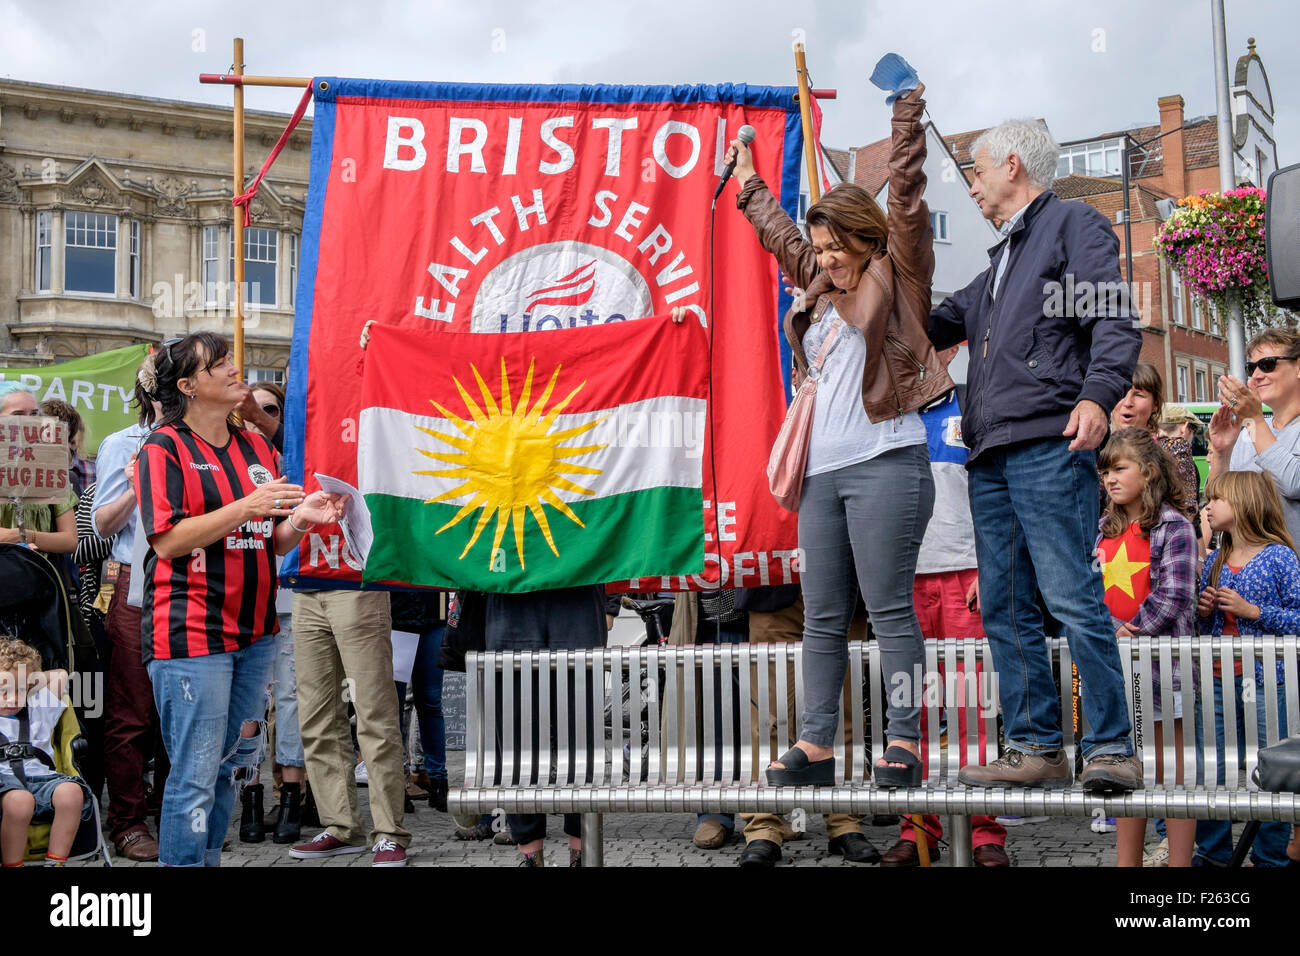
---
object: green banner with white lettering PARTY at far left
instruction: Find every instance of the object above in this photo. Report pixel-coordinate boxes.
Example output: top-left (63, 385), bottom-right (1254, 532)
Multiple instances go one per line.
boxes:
top-left (0, 345), bottom-right (150, 458)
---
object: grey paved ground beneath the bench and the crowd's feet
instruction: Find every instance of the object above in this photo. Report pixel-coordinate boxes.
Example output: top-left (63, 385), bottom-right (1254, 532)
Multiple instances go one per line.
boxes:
top-left (73, 752), bottom-right (1175, 868)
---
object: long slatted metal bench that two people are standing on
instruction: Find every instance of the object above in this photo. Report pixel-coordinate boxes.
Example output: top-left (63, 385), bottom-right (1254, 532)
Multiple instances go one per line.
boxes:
top-left (449, 636), bottom-right (1300, 866)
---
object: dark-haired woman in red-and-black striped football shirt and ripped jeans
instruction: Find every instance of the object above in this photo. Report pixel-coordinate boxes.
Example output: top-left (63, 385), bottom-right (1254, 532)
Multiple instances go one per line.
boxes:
top-left (137, 332), bottom-right (341, 866)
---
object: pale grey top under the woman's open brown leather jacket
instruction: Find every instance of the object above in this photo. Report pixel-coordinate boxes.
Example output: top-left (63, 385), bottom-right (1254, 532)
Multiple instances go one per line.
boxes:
top-left (803, 306), bottom-right (926, 475)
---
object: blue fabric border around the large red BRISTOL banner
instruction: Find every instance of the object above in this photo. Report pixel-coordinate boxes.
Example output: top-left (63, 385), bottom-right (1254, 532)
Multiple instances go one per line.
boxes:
top-left (287, 77), bottom-right (803, 591)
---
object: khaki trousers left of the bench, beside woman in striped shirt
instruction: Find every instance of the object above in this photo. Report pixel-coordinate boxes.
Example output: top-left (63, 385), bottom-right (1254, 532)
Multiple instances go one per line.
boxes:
top-left (294, 591), bottom-right (411, 847)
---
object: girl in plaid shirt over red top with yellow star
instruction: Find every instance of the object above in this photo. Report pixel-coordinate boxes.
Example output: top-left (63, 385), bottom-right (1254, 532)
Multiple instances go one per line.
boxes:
top-left (1097, 428), bottom-right (1196, 866)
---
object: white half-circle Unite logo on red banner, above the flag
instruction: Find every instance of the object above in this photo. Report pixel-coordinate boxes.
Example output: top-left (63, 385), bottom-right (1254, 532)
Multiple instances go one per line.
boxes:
top-left (471, 239), bottom-right (651, 332)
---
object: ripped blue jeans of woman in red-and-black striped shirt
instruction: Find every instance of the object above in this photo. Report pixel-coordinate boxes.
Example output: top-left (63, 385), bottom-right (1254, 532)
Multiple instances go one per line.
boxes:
top-left (148, 636), bottom-right (276, 866)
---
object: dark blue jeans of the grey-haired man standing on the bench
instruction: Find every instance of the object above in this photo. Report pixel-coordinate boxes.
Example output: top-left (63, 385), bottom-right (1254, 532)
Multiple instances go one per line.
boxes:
top-left (970, 438), bottom-right (1132, 758)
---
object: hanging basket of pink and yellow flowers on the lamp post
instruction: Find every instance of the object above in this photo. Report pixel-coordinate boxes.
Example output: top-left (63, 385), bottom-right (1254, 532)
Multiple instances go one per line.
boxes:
top-left (1154, 186), bottom-right (1277, 316)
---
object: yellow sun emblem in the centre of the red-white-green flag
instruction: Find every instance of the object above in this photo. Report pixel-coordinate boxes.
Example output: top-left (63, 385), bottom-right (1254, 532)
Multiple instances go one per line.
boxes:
top-left (415, 358), bottom-right (607, 568)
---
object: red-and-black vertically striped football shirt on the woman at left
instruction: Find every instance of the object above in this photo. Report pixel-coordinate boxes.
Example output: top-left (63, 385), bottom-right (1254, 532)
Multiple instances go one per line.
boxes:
top-left (137, 421), bottom-right (280, 662)
